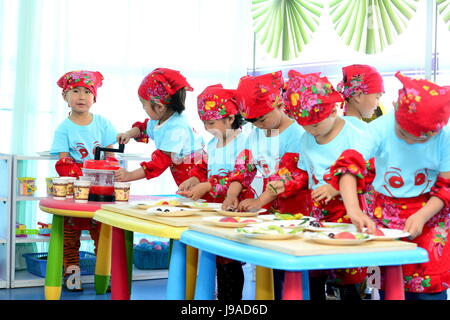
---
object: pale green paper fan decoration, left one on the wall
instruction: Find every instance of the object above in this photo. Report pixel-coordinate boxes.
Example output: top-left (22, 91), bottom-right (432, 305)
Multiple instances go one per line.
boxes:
top-left (252, 0), bottom-right (323, 61)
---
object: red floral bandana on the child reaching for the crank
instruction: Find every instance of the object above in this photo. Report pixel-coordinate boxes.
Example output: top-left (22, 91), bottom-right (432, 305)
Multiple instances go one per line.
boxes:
top-left (138, 68), bottom-right (194, 104)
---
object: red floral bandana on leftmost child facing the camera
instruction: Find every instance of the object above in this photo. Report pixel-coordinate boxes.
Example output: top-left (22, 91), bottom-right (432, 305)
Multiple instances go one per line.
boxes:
top-left (56, 70), bottom-right (104, 101)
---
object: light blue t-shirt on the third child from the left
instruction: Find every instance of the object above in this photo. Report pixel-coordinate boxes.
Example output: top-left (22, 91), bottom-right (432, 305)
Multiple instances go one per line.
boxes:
top-left (207, 131), bottom-right (248, 178)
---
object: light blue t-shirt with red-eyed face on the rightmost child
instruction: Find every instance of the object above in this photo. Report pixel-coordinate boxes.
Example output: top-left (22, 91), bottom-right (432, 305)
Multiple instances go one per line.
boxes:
top-left (357, 112), bottom-right (450, 198)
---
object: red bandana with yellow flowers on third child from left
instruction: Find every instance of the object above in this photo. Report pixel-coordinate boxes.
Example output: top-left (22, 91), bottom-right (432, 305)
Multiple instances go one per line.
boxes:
top-left (197, 84), bottom-right (238, 120)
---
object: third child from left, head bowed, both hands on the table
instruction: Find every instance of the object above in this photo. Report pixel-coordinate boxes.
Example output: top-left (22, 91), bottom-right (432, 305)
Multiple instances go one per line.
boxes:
top-left (179, 84), bottom-right (256, 300)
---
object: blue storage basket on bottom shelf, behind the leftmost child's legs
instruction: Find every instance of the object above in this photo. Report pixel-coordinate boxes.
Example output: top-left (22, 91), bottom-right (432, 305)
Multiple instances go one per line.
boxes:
top-left (23, 251), bottom-right (96, 278)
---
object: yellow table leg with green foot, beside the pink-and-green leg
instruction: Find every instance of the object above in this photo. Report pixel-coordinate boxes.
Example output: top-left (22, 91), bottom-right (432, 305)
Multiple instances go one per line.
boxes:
top-left (94, 223), bottom-right (111, 294)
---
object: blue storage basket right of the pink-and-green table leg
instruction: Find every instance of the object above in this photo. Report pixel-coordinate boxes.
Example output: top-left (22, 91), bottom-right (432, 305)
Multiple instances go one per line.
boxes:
top-left (133, 246), bottom-right (169, 270)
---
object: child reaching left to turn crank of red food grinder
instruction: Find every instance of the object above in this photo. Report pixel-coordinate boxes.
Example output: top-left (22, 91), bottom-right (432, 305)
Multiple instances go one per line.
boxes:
top-left (115, 68), bottom-right (204, 186)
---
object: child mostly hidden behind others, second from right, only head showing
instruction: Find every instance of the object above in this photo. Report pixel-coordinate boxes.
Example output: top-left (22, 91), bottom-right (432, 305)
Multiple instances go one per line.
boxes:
top-left (337, 64), bottom-right (384, 128)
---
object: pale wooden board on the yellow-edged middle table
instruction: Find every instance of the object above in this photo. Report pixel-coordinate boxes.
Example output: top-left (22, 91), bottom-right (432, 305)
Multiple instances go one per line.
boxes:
top-left (102, 204), bottom-right (217, 227)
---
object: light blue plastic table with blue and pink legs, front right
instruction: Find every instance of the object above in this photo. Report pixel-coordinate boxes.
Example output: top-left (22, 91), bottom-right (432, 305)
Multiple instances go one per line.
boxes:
top-left (180, 225), bottom-right (428, 300)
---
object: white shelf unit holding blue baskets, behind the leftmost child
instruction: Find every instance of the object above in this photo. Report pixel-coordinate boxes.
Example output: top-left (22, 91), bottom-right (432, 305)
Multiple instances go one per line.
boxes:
top-left (10, 154), bottom-right (168, 288)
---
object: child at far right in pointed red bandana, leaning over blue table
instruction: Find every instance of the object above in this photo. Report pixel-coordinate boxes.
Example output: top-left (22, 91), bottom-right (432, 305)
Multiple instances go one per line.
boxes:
top-left (331, 72), bottom-right (450, 300)
